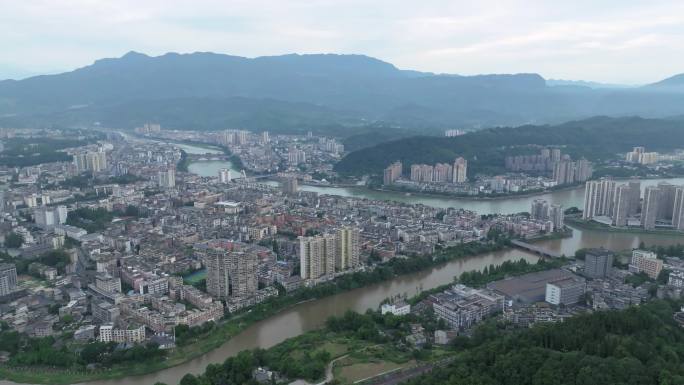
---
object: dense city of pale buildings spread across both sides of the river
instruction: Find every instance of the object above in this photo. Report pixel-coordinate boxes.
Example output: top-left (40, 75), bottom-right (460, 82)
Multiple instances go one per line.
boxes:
top-left (0, 123), bottom-right (684, 385)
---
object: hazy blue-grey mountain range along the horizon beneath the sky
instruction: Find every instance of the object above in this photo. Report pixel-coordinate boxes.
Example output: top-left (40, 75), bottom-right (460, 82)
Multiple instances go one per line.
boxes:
top-left (0, 52), bottom-right (684, 130)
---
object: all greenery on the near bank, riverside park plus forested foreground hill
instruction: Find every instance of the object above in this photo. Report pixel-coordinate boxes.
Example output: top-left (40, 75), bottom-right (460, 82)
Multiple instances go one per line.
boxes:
top-left (157, 261), bottom-right (684, 385)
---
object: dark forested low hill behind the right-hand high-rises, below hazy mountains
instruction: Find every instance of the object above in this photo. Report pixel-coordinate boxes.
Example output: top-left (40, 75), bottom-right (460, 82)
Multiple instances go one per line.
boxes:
top-left (335, 117), bottom-right (684, 175)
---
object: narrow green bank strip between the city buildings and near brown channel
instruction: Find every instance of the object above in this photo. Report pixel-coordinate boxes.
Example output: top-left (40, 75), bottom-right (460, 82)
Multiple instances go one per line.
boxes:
top-left (0, 242), bottom-right (507, 385)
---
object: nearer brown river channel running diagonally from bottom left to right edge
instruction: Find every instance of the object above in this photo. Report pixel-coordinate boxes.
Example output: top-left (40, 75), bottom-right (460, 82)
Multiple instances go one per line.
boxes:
top-left (52, 225), bottom-right (684, 385)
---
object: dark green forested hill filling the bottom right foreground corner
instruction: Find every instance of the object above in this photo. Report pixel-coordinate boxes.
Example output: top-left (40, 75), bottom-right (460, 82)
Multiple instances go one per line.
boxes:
top-left (409, 302), bottom-right (684, 385)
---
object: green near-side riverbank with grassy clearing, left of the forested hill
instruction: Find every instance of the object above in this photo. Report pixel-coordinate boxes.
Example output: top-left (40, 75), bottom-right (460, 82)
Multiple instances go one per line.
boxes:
top-left (160, 255), bottom-right (567, 384)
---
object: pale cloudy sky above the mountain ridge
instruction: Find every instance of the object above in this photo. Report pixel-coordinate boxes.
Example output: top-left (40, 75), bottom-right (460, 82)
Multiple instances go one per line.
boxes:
top-left (0, 0), bottom-right (684, 84)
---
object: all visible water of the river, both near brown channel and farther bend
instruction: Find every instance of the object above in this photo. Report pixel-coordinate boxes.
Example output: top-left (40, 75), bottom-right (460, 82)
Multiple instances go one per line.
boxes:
top-left (0, 156), bottom-right (684, 385)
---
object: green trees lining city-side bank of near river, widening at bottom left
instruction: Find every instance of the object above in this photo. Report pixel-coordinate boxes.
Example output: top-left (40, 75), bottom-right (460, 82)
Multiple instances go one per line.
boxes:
top-left (0, 235), bottom-right (508, 384)
